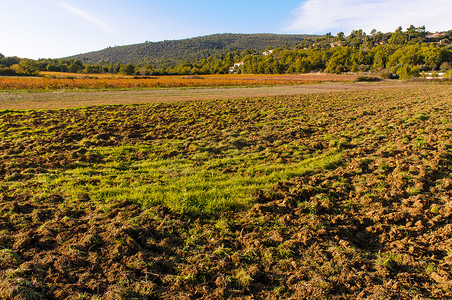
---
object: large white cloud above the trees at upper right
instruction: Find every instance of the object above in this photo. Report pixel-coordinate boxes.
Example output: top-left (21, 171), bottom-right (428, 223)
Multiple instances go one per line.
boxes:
top-left (287, 0), bottom-right (452, 34)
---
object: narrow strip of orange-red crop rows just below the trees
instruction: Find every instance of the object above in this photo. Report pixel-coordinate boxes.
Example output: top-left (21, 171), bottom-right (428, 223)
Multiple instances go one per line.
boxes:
top-left (0, 72), bottom-right (357, 90)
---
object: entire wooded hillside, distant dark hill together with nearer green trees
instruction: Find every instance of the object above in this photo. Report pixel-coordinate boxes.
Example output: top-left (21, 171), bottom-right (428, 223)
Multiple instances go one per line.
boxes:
top-left (0, 25), bottom-right (452, 79)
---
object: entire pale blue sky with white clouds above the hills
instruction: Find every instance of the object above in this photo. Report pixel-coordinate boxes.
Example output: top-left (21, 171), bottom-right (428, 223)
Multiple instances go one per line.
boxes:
top-left (0, 0), bottom-right (452, 59)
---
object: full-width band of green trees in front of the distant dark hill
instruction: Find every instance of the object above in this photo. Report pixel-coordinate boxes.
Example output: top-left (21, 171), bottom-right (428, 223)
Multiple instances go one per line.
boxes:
top-left (0, 25), bottom-right (452, 79)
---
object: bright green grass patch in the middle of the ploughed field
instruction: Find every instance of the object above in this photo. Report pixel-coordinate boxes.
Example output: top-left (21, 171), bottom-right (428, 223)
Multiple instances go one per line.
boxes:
top-left (35, 148), bottom-right (341, 215)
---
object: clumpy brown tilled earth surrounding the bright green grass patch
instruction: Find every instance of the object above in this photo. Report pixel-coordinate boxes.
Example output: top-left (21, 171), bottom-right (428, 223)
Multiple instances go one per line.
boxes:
top-left (0, 85), bottom-right (452, 299)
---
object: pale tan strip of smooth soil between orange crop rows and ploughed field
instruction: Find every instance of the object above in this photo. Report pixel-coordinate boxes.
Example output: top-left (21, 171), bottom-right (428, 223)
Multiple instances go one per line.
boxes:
top-left (0, 81), bottom-right (410, 109)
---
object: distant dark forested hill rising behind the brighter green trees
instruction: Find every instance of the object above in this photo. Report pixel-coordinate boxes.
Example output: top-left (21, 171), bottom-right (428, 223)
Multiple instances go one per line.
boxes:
top-left (68, 33), bottom-right (316, 67)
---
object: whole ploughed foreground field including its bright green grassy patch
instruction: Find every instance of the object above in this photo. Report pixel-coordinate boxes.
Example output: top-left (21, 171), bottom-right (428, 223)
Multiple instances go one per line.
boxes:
top-left (0, 81), bottom-right (452, 299)
